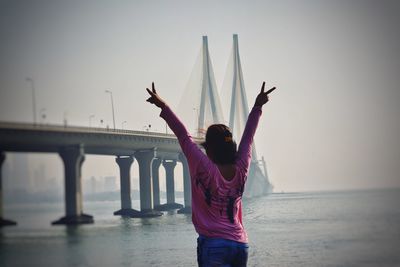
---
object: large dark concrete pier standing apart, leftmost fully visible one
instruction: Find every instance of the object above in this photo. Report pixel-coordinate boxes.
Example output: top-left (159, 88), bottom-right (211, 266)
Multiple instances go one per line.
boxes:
top-left (52, 144), bottom-right (93, 224)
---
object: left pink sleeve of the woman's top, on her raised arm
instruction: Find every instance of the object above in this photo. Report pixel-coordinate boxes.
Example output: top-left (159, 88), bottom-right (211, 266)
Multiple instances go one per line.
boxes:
top-left (160, 105), bottom-right (208, 176)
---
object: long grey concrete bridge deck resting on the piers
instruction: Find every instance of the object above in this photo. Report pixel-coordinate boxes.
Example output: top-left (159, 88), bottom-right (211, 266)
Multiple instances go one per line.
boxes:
top-left (0, 122), bottom-right (201, 155)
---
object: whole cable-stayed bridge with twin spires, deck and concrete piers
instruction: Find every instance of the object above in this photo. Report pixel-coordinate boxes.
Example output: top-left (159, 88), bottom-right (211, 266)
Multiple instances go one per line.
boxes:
top-left (0, 35), bottom-right (272, 226)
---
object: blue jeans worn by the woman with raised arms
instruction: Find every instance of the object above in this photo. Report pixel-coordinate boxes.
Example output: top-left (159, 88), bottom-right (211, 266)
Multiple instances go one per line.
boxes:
top-left (197, 235), bottom-right (249, 267)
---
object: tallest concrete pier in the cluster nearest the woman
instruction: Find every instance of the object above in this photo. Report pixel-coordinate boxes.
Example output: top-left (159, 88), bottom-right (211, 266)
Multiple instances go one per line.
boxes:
top-left (135, 149), bottom-right (162, 218)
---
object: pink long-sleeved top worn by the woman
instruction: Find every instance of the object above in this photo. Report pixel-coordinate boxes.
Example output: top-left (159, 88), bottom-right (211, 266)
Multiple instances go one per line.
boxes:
top-left (160, 105), bottom-right (262, 243)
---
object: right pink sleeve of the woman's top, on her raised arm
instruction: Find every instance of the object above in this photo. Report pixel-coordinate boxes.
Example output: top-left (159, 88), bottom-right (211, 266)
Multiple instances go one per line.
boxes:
top-left (236, 106), bottom-right (262, 176)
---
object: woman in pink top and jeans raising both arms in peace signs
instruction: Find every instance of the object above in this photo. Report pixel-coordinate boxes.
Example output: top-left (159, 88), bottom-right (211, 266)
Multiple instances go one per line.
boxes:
top-left (146, 82), bottom-right (275, 266)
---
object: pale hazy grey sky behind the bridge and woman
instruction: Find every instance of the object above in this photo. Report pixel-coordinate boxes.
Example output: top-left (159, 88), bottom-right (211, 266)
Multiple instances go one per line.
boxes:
top-left (0, 0), bottom-right (400, 191)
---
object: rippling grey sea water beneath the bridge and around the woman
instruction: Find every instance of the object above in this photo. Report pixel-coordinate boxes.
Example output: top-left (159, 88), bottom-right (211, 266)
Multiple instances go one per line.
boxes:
top-left (0, 189), bottom-right (400, 266)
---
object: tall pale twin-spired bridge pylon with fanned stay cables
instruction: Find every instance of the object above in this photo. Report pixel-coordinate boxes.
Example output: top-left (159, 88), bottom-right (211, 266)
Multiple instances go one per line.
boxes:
top-left (184, 34), bottom-right (272, 197)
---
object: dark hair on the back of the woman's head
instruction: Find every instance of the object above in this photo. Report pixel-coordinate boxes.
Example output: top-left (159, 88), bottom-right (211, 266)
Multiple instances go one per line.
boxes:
top-left (202, 124), bottom-right (236, 164)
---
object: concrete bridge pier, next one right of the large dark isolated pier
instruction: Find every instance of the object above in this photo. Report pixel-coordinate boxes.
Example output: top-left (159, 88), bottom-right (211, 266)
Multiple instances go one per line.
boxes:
top-left (114, 156), bottom-right (140, 217)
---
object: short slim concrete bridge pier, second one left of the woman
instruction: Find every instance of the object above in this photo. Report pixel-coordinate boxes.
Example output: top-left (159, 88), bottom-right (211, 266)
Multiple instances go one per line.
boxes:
top-left (158, 159), bottom-right (183, 211)
